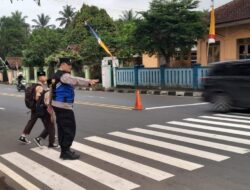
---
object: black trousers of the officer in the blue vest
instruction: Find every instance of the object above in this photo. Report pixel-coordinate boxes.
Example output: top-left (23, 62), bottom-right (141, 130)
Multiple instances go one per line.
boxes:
top-left (53, 107), bottom-right (76, 152)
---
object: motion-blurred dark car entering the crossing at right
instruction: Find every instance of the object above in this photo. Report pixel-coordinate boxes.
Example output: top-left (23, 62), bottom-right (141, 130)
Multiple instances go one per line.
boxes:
top-left (203, 59), bottom-right (250, 112)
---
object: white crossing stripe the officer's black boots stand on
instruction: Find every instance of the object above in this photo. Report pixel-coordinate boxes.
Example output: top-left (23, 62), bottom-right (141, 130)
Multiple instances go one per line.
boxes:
top-left (31, 148), bottom-right (140, 190)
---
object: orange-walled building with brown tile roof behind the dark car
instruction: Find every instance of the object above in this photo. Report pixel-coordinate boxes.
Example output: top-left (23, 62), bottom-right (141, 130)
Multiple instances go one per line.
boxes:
top-left (197, 0), bottom-right (250, 65)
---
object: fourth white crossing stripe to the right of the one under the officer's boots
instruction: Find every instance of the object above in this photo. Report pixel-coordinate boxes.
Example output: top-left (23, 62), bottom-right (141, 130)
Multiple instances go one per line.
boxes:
top-left (129, 124), bottom-right (249, 154)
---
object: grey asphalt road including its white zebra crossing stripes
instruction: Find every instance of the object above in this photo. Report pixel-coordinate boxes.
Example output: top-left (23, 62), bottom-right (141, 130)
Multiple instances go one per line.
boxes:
top-left (0, 85), bottom-right (250, 190)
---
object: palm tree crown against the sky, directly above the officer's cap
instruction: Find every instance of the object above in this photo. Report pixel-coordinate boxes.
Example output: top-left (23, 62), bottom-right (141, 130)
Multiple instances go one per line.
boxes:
top-left (56, 5), bottom-right (76, 28)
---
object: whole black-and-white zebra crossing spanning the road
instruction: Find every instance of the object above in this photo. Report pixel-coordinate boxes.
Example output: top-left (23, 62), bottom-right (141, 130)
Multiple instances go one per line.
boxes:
top-left (0, 113), bottom-right (250, 190)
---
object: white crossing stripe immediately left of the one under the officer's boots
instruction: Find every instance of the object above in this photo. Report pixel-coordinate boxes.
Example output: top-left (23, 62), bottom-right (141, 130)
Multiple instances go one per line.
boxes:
top-left (1, 152), bottom-right (84, 190)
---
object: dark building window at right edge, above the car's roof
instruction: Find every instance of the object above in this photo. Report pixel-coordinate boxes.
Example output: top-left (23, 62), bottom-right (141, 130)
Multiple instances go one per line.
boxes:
top-left (237, 38), bottom-right (250, 59)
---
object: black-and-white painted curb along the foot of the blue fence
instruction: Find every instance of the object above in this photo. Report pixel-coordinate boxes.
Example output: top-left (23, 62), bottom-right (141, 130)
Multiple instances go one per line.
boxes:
top-left (76, 87), bottom-right (202, 97)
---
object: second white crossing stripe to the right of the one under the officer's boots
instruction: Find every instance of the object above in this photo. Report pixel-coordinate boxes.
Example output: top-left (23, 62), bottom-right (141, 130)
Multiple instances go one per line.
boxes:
top-left (85, 136), bottom-right (203, 171)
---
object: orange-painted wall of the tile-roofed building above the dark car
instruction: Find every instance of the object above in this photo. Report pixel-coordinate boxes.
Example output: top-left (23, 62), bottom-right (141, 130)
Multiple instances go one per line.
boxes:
top-left (197, 24), bottom-right (250, 66)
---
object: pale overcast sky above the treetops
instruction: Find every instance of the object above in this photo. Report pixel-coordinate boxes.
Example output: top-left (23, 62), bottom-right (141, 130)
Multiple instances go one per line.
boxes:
top-left (0, 0), bottom-right (232, 26)
